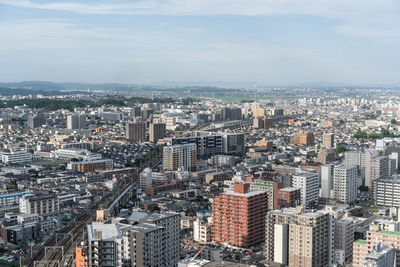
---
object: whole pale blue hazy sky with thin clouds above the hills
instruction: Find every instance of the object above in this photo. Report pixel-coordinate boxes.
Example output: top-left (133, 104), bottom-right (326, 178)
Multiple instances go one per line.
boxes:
top-left (0, 0), bottom-right (400, 85)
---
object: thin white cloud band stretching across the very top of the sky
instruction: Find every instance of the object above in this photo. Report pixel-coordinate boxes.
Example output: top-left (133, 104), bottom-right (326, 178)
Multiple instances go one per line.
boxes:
top-left (0, 0), bottom-right (400, 41)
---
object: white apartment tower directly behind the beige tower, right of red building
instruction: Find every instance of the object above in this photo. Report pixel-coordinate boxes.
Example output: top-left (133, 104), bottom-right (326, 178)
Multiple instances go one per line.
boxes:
top-left (292, 172), bottom-right (319, 208)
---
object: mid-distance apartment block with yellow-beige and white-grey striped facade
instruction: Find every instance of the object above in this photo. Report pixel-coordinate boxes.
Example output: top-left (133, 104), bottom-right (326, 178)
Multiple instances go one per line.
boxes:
top-left (163, 144), bottom-right (197, 171)
